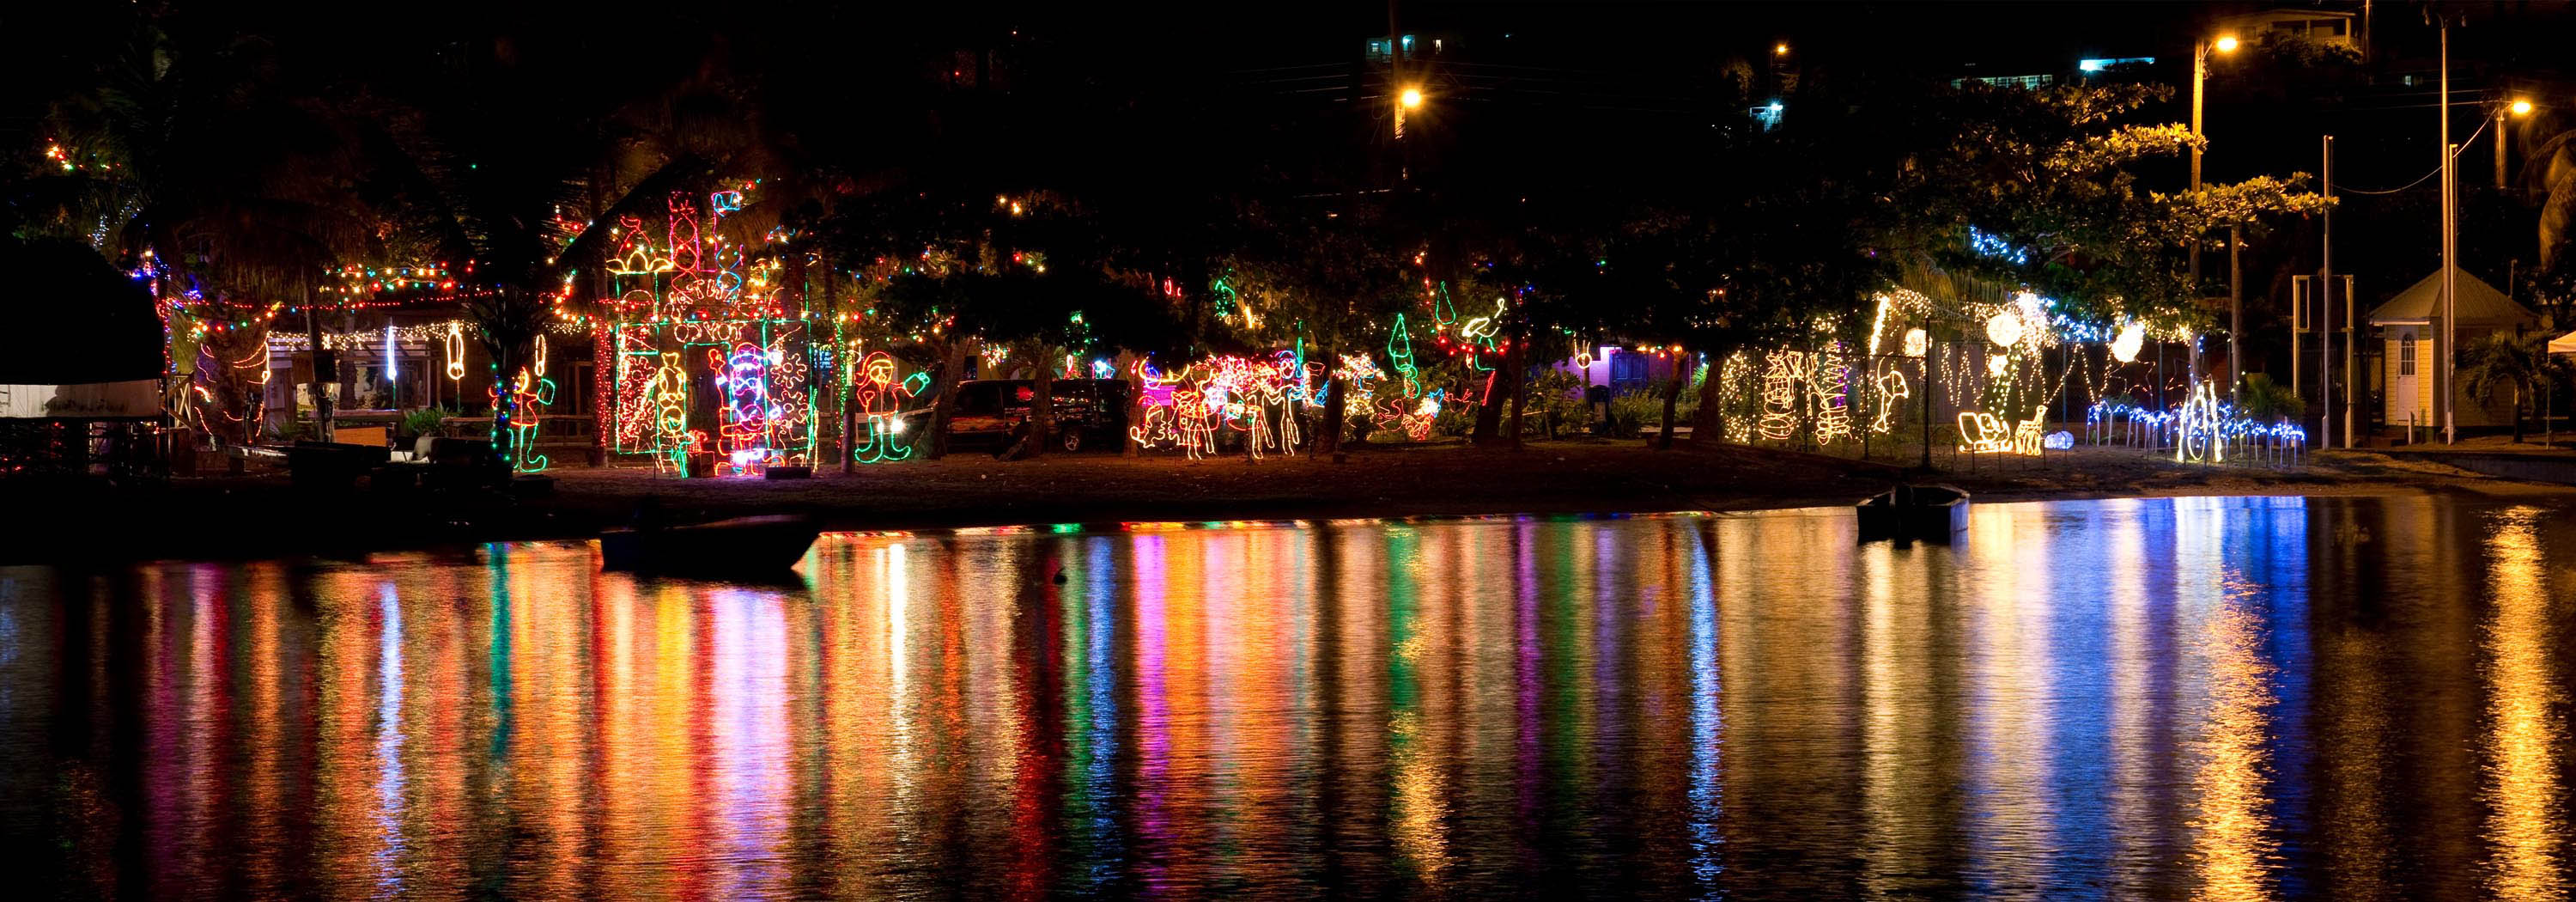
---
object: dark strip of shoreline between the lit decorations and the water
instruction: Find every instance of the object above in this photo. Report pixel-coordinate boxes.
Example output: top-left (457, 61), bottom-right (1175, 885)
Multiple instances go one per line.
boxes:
top-left (0, 441), bottom-right (2576, 567)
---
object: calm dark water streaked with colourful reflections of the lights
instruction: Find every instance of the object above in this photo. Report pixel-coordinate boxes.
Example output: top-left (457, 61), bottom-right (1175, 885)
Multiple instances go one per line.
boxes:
top-left (0, 497), bottom-right (2576, 899)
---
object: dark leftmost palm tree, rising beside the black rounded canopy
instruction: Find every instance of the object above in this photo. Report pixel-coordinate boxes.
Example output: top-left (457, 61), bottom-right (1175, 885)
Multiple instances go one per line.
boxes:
top-left (10, 10), bottom-right (376, 441)
